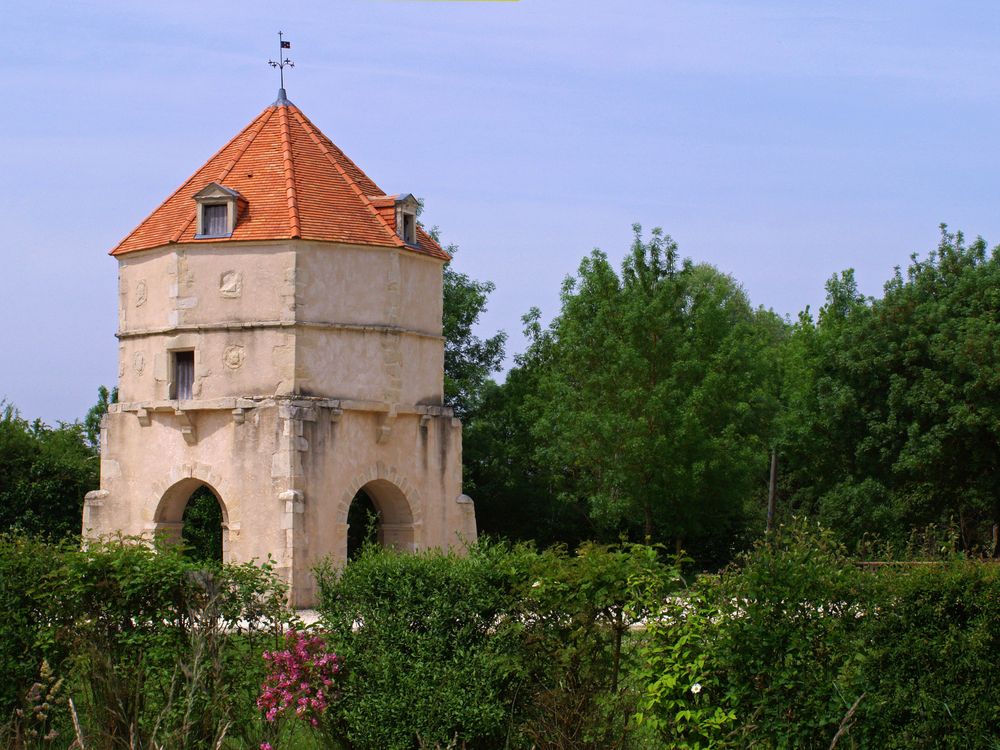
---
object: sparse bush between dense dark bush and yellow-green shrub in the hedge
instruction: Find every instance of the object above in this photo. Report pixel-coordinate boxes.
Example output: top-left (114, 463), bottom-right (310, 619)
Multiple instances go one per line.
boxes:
top-left (522, 544), bottom-right (680, 750)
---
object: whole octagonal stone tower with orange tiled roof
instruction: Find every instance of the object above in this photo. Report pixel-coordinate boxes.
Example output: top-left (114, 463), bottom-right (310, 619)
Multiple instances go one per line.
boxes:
top-left (83, 89), bottom-right (476, 607)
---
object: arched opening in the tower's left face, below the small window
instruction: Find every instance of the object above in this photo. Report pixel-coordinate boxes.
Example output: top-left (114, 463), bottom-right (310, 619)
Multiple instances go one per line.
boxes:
top-left (153, 478), bottom-right (229, 562)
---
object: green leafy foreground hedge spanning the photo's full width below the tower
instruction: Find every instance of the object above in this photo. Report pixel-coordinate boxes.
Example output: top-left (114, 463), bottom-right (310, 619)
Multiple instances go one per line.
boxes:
top-left (0, 522), bottom-right (1000, 750)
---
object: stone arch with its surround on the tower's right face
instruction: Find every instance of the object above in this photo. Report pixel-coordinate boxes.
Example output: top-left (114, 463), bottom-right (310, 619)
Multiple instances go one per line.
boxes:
top-left (336, 462), bottom-right (423, 560)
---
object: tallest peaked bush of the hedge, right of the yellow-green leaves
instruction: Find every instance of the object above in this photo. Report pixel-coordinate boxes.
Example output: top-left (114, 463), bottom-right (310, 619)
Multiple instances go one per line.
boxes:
top-left (708, 521), bottom-right (868, 749)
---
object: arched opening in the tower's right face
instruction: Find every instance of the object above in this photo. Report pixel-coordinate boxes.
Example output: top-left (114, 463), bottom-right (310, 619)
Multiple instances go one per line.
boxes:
top-left (347, 479), bottom-right (414, 560)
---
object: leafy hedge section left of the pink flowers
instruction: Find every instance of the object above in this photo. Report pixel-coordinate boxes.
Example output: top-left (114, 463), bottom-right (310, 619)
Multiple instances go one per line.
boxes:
top-left (0, 537), bottom-right (290, 748)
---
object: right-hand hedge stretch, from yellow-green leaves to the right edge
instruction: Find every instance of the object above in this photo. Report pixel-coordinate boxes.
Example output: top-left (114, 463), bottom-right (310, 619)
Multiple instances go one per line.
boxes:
top-left (641, 521), bottom-right (1000, 750)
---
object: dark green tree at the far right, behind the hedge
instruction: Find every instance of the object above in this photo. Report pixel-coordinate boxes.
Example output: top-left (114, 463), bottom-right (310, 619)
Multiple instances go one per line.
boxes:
top-left (782, 227), bottom-right (1000, 551)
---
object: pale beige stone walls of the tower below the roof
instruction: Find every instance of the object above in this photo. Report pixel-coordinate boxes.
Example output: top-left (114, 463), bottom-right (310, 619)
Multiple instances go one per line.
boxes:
top-left (83, 241), bottom-right (476, 606)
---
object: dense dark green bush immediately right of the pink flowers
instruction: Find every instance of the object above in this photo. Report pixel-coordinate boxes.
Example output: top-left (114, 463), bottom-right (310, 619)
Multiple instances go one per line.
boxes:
top-left (317, 544), bottom-right (524, 750)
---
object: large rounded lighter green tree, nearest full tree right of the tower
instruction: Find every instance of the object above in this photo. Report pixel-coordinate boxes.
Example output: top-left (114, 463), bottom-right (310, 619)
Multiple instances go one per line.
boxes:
top-left (528, 226), bottom-right (784, 545)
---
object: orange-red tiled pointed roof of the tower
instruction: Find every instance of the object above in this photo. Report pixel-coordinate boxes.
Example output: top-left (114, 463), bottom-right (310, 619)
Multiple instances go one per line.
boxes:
top-left (111, 99), bottom-right (450, 260)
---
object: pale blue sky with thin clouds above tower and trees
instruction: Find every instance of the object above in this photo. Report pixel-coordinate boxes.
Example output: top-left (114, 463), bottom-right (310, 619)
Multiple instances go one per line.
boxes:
top-left (0, 0), bottom-right (1000, 422)
